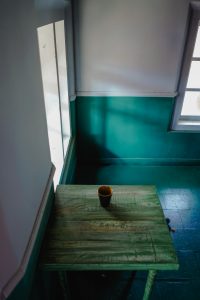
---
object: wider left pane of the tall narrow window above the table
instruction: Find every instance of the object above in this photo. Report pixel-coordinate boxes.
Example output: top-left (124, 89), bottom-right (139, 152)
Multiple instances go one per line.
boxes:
top-left (38, 24), bottom-right (63, 185)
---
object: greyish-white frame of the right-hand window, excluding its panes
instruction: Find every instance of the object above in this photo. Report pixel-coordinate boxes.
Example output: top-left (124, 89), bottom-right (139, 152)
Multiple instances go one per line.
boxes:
top-left (171, 1), bottom-right (200, 131)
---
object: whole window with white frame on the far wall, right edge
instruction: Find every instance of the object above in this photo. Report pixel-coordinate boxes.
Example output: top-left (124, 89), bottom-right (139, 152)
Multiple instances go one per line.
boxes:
top-left (172, 2), bottom-right (200, 131)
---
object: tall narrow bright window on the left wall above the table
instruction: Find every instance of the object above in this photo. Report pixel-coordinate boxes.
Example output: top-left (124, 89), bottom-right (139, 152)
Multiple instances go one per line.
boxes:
top-left (37, 21), bottom-right (70, 185)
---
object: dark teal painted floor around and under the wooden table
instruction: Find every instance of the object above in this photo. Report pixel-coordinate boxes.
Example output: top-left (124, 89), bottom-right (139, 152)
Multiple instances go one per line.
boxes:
top-left (69, 165), bottom-right (200, 300)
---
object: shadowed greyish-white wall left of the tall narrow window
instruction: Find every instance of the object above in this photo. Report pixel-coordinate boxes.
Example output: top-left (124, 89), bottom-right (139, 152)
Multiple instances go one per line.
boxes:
top-left (0, 0), bottom-right (64, 294)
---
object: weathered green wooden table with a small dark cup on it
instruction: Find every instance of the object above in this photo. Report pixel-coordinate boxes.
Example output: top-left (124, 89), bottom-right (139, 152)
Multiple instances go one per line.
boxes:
top-left (40, 185), bottom-right (179, 300)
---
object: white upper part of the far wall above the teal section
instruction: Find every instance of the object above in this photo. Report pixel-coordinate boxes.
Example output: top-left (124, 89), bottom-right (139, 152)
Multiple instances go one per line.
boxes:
top-left (75, 0), bottom-right (197, 95)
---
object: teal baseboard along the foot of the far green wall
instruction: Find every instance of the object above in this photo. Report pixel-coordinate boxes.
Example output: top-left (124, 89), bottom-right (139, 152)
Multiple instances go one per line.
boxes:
top-left (79, 158), bottom-right (200, 166)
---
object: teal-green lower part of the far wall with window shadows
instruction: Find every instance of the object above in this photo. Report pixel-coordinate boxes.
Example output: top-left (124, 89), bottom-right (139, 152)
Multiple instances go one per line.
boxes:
top-left (76, 97), bottom-right (200, 163)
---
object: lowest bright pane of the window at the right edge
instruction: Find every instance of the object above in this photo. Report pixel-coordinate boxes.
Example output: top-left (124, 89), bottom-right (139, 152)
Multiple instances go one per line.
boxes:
top-left (181, 92), bottom-right (200, 116)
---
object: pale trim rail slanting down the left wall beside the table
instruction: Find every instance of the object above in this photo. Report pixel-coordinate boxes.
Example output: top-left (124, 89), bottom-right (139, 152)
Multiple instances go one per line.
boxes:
top-left (1, 165), bottom-right (55, 300)
